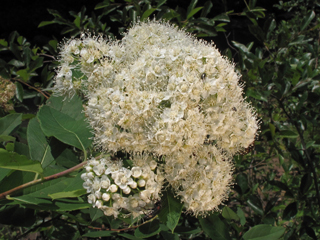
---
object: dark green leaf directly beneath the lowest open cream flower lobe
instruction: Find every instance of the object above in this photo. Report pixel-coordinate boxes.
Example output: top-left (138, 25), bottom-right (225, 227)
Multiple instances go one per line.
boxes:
top-left (199, 214), bottom-right (231, 240)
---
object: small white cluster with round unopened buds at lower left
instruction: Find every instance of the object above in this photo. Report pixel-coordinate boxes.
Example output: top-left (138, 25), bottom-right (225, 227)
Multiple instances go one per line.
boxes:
top-left (81, 156), bottom-right (163, 218)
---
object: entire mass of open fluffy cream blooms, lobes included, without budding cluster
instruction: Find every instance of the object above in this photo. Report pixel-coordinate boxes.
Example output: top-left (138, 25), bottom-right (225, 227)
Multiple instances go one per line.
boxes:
top-left (55, 21), bottom-right (258, 215)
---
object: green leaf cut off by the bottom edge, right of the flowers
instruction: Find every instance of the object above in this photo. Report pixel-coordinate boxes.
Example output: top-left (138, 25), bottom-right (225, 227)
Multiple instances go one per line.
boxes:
top-left (243, 224), bottom-right (285, 240)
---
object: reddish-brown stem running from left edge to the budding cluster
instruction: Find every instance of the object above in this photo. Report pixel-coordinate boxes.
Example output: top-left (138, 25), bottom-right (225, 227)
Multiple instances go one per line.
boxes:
top-left (0, 161), bottom-right (87, 200)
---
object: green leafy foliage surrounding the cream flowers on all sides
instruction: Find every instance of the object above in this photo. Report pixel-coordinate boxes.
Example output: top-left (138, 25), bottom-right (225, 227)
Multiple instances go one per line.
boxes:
top-left (0, 0), bottom-right (320, 240)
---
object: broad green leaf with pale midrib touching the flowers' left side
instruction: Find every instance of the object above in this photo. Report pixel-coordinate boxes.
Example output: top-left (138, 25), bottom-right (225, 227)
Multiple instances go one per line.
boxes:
top-left (38, 106), bottom-right (92, 151)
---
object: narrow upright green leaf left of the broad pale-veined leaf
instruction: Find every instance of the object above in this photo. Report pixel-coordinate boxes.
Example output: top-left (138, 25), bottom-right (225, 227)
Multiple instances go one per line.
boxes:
top-left (27, 118), bottom-right (54, 168)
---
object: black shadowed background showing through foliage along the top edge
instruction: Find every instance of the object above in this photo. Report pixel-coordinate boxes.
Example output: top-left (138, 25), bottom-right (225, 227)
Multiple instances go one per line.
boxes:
top-left (0, 0), bottom-right (287, 49)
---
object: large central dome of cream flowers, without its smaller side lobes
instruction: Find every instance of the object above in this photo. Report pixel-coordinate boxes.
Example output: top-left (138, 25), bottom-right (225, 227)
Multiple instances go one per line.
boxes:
top-left (82, 21), bottom-right (258, 156)
